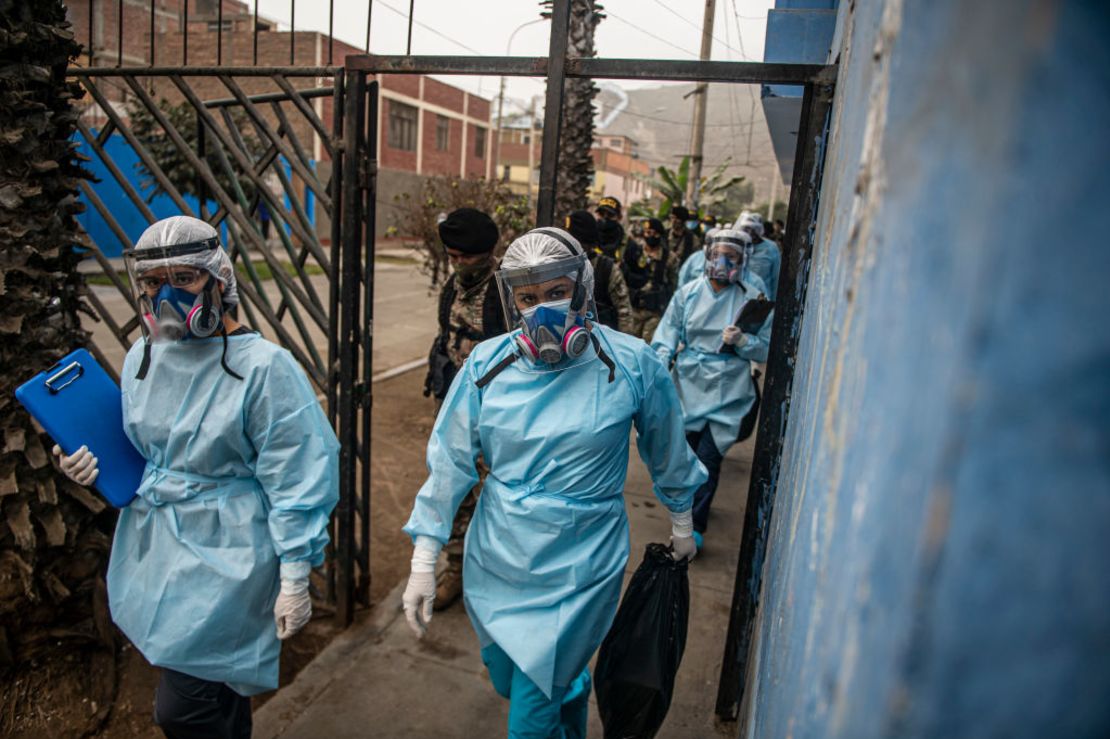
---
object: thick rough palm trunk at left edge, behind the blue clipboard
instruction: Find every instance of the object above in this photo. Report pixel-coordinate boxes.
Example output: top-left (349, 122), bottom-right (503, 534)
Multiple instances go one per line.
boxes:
top-left (0, 0), bottom-right (114, 733)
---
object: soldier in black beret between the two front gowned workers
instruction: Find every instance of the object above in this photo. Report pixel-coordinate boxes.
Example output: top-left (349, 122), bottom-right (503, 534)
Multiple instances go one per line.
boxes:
top-left (424, 207), bottom-right (505, 610)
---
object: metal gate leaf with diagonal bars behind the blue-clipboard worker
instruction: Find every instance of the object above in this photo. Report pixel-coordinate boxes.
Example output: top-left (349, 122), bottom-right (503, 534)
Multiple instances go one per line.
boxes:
top-left (70, 67), bottom-right (373, 624)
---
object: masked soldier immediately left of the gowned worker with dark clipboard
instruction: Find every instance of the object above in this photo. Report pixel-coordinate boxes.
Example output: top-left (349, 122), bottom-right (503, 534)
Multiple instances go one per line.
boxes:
top-left (620, 219), bottom-right (679, 342)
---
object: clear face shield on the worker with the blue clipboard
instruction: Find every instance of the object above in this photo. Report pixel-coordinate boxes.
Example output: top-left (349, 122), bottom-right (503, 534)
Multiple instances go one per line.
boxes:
top-left (123, 236), bottom-right (223, 342)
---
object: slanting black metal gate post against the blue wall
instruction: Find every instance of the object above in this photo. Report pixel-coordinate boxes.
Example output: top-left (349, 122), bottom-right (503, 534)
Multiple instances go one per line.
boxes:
top-left (716, 75), bottom-right (835, 721)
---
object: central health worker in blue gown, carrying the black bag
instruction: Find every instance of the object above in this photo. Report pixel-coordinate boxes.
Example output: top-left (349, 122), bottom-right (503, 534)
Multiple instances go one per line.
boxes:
top-left (404, 229), bottom-right (706, 738)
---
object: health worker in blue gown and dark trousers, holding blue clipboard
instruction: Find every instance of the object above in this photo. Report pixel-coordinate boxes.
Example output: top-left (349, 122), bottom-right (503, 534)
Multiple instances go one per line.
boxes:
top-left (54, 216), bottom-right (339, 739)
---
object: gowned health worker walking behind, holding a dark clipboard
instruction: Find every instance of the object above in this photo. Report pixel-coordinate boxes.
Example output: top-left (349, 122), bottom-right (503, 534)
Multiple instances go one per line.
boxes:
top-left (652, 229), bottom-right (771, 548)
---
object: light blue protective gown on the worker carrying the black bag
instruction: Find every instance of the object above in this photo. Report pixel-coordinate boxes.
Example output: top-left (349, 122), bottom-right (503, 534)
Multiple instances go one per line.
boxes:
top-left (404, 326), bottom-right (706, 698)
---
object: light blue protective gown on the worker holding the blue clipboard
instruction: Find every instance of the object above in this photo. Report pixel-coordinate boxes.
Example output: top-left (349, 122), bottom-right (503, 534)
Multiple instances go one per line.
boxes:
top-left (108, 334), bottom-right (339, 696)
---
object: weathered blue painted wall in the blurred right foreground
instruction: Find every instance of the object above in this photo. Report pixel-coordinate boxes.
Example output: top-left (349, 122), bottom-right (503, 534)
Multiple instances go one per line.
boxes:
top-left (740, 0), bottom-right (1110, 739)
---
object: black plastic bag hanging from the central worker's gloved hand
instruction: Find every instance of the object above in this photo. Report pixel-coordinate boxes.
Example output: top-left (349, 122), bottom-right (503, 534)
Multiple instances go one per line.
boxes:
top-left (594, 544), bottom-right (690, 739)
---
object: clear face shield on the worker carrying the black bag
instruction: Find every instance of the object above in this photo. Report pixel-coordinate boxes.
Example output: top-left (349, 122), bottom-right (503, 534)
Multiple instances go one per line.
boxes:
top-left (496, 254), bottom-right (597, 368)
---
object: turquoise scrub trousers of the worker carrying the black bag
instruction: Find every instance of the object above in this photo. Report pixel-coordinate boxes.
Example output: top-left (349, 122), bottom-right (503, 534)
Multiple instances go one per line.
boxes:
top-left (482, 644), bottom-right (591, 739)
